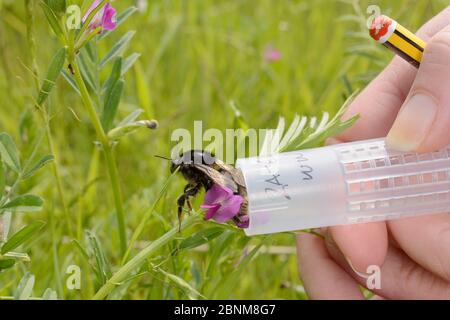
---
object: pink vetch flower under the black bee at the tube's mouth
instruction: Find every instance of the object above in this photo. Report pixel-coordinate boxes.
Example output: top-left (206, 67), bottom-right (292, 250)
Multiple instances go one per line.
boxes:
top-left (200, 184), bottom-right (245, 224)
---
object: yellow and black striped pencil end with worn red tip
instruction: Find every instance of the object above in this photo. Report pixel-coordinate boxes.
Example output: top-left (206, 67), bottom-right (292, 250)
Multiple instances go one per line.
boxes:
top-left (369, 16), bottom-right (426, 68)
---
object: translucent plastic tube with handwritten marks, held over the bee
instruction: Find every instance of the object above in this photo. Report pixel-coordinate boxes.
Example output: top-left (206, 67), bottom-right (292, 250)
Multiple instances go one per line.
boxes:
top-left (237, 139), bottom-right (450, 235)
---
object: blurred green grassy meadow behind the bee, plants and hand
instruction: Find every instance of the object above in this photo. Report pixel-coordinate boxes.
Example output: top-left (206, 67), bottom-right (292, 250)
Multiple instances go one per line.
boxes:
top-left (0, 0), bottom-right (448, 299)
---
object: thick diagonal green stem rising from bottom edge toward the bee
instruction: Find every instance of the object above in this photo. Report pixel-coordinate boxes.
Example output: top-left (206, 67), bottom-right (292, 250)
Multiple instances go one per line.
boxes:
top-left (93, 214), bottom-right (201, 300)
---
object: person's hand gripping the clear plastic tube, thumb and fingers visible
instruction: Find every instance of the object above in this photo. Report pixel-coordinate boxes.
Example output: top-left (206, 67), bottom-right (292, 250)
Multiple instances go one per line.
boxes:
top-left (297, 7), bottom-right (450, 299)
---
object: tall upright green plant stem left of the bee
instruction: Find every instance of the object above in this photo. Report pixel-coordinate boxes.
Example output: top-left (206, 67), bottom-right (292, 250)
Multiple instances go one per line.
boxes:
top-left (69, 57), bottom-right (127, 256)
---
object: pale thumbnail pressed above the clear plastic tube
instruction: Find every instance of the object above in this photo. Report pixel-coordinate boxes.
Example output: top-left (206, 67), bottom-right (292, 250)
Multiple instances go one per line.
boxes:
top-left (386, 94), bottom-right (438, 152)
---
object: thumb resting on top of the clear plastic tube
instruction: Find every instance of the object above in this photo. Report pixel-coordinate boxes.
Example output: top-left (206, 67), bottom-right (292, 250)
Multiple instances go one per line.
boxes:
top-left (386, 26), bottom-right (450, 152)
